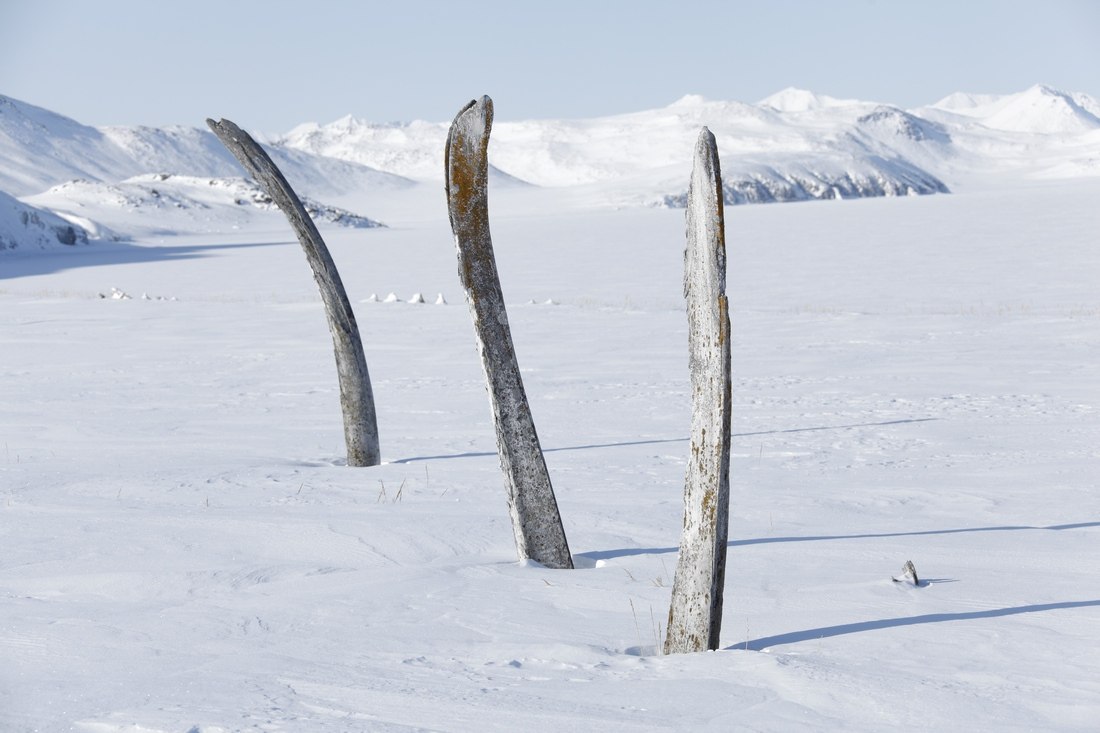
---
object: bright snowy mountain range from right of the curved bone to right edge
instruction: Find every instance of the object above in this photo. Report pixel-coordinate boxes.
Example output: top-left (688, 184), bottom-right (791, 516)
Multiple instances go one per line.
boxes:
top-left (275, 86), bottom-right (1100, 205)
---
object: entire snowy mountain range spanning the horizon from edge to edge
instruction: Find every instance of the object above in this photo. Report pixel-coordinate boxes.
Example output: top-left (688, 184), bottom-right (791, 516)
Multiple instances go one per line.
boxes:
top-left (0, 86), bottom-right (1100, 244)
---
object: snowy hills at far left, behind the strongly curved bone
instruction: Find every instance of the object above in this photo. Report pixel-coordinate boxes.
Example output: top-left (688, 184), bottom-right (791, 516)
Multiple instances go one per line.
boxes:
top-left (0, 96), bottom-right (404, 242)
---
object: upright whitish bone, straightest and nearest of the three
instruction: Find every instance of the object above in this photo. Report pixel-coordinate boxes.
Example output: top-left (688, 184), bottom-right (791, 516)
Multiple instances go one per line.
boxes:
top-left (664, 128), bottom-right (732, 654)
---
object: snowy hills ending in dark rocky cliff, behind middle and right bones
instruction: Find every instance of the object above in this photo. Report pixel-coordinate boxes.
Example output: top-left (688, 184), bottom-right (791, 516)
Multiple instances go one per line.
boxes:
top-left (276, 90), bottom-right (947, 205)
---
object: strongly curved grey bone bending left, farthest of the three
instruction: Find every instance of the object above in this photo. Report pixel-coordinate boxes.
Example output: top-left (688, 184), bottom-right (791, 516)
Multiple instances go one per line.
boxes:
top-left (207, 119), bottom-right (382, 466)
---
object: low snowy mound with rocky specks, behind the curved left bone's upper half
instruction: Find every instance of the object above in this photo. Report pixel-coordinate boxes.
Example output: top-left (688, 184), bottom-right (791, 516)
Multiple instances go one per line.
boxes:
top-left (26, 173), bottom-right (385, 233)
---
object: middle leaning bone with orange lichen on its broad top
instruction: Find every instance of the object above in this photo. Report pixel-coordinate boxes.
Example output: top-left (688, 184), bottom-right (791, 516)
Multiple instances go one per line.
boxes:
top-left (446, 97), bottom-right (573, 568)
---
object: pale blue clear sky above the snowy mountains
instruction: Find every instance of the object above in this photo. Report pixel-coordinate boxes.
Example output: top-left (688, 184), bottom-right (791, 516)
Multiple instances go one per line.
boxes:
top-left (0, 0), bottom-right (1100, 133)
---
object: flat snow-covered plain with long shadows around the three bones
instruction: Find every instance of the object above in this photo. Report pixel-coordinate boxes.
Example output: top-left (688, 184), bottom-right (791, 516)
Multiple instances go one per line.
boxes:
top-left (0, 88), bottom-right (1100, 733)
